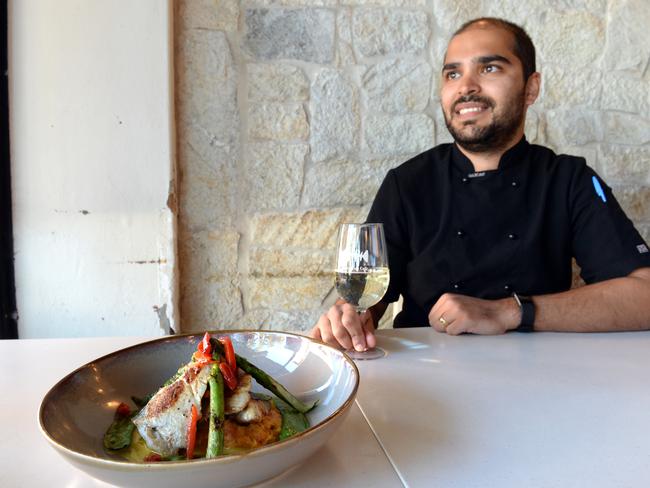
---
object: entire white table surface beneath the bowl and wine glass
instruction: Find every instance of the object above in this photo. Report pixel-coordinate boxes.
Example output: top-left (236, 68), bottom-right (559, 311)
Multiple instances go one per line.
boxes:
top-left (0, 328), bottom-right (650, 488)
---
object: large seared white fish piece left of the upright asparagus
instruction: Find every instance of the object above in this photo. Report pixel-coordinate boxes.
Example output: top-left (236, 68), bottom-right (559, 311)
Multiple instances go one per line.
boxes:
top-left (133, 365), bottom-right (211, 456)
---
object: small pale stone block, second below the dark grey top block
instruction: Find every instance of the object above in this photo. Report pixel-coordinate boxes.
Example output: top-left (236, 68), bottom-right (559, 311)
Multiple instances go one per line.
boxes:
top-left (248, 102), bottom-right (309, 141)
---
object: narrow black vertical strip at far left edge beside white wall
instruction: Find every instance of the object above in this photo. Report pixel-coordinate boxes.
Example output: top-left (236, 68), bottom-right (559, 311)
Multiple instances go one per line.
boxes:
top-left (0, 1), bottom-right (18, 339)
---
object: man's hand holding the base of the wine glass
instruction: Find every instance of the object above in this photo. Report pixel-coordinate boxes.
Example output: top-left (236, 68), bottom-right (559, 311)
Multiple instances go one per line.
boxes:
top-left (309, 302), bottom-right (376, 351)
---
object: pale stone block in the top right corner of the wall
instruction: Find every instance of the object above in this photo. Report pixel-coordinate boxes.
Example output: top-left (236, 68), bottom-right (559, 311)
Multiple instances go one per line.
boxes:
top-left (604, 0), bottom-right (650, 73)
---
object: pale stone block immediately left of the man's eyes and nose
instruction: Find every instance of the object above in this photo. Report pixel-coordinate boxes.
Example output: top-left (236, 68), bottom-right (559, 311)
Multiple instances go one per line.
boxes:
top-left (362, 59), bottom-right (431, 114)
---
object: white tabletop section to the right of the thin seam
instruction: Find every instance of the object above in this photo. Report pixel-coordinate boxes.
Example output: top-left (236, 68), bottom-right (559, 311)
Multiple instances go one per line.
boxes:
top-left (357, 328), bottom-right (650, 488)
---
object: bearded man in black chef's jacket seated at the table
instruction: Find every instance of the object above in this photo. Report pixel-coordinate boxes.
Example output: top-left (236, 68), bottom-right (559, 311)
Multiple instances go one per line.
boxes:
top-left (311, 18), bottom-right (650, 351)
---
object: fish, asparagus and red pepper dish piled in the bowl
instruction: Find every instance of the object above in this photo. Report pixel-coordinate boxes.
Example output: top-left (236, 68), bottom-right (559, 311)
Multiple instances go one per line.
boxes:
top-left (104, 332), bottom-right (317, 462)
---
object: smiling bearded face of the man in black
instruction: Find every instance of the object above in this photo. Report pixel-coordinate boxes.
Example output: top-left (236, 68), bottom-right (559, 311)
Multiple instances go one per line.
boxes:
top-left (441, 26), bottom-right (536, 152)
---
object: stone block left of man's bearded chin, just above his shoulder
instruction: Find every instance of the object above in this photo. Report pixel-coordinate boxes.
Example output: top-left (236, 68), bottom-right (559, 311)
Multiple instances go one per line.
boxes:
top-left (364, 114), bottom-right (435, 156)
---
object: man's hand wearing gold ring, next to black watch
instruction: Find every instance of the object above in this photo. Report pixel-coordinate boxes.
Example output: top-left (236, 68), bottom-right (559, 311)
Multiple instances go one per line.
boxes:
top-left (429, 293), bottom-right (521, 335)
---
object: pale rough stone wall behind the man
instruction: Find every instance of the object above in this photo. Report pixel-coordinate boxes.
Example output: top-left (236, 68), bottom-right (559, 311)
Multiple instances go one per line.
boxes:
top-left (175, 0), bottom-right (650, 331)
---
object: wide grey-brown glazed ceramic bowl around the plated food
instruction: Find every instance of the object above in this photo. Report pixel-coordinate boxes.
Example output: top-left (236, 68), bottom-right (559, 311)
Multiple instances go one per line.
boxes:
top-left (39, 331), bottom-right (359, 488)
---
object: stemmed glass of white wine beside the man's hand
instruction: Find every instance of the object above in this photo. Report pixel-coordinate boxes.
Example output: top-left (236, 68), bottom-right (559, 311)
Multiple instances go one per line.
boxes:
top-left (336, 223), bottom-right (390, 359)
